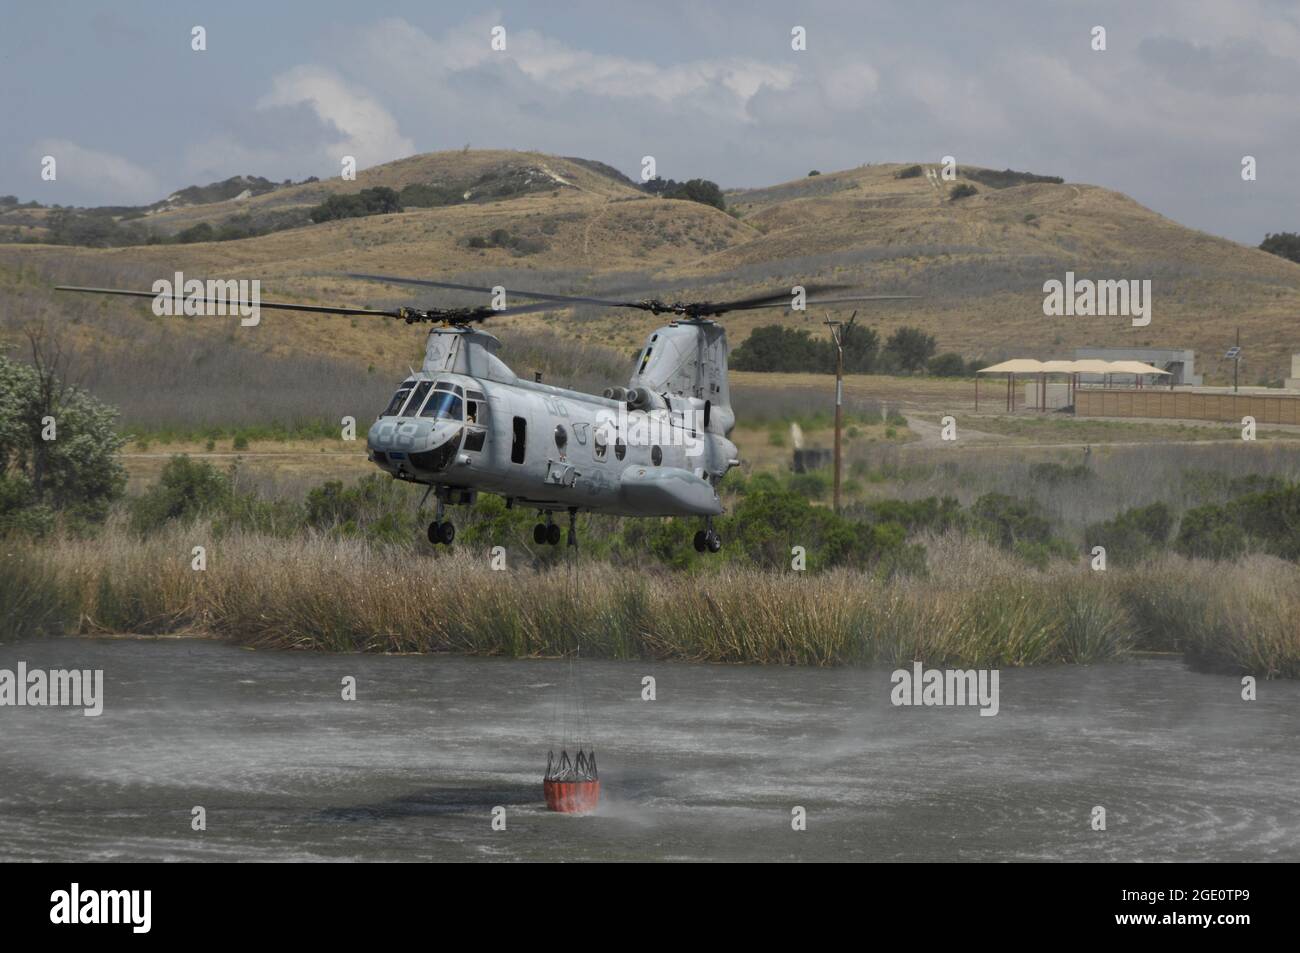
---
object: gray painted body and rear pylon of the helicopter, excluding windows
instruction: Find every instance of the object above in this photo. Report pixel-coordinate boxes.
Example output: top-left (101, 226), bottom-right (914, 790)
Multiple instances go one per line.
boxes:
top-left (367, 321), bottom-right (738, 516)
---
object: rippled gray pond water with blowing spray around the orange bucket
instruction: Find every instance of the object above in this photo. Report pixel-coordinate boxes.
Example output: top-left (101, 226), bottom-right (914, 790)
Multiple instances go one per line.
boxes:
top-left (0, 638), bottom-right (1300, 861)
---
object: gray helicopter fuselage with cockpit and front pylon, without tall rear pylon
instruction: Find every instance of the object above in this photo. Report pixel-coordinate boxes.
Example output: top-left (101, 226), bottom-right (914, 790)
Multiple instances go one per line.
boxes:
top-left (367, 329), bottom-right (737, 516)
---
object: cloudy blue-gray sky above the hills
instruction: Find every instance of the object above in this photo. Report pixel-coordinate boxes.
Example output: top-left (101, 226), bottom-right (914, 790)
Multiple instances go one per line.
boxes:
top-left (0, 0), bottom-right (1300, 244)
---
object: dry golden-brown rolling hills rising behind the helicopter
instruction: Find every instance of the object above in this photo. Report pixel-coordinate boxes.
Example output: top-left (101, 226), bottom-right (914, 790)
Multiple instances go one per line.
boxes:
top-left (0, 151), bottom-right (1300, 408)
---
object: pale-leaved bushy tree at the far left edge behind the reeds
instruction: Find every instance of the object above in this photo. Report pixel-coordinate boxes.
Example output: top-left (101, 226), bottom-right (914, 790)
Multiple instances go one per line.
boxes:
top-left (0, 332), bottom-right (126, 528)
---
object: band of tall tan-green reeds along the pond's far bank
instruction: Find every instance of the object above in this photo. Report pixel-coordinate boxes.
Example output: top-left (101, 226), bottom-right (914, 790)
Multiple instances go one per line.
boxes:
top-left (0, 524), bottom-right (1300, 677)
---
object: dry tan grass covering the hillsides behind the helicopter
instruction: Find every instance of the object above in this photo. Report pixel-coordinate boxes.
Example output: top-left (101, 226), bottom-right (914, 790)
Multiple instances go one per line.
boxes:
top-left (5, 152), bottom-right (1300, 381)
